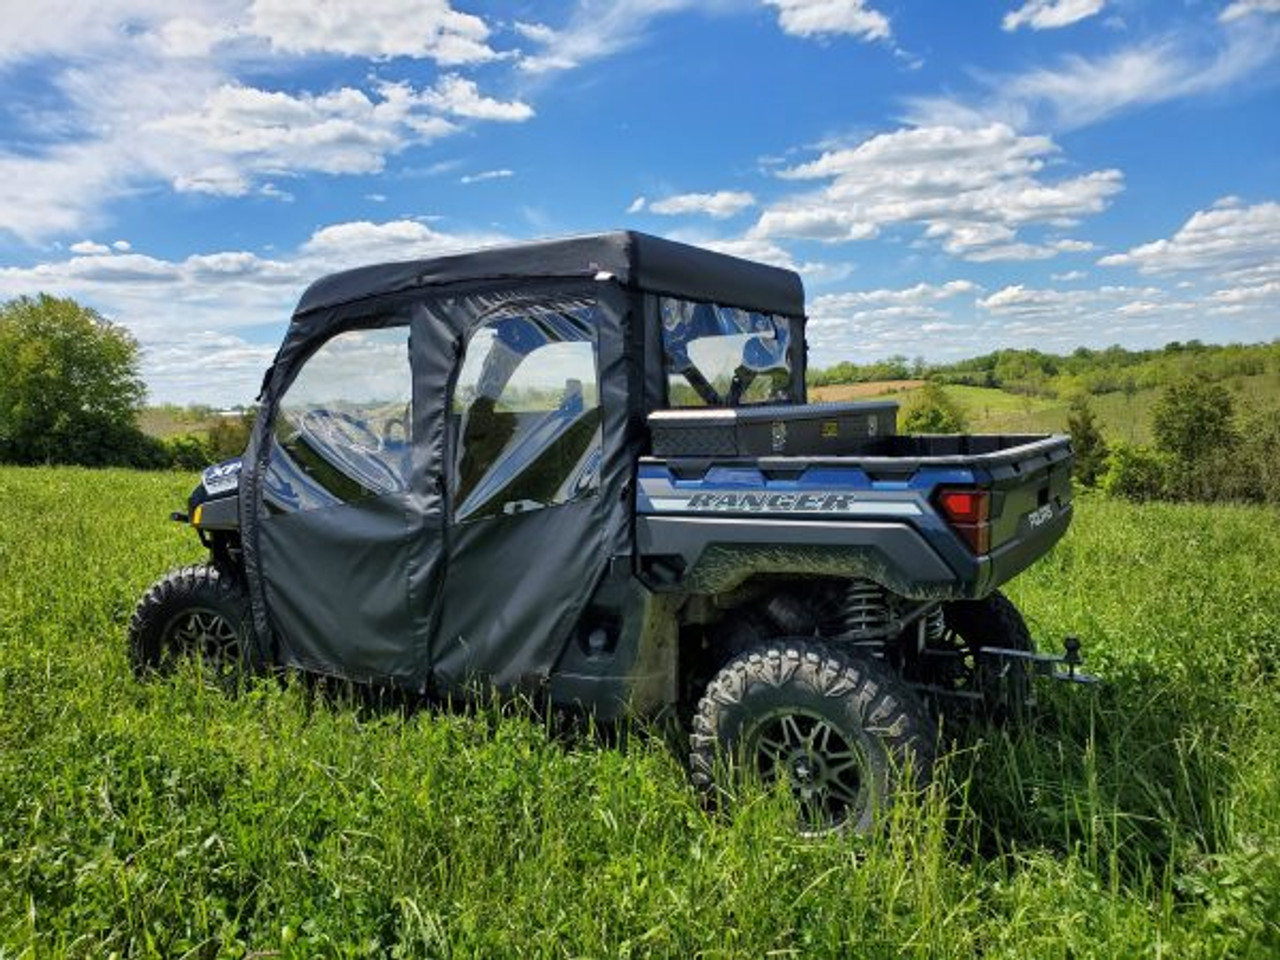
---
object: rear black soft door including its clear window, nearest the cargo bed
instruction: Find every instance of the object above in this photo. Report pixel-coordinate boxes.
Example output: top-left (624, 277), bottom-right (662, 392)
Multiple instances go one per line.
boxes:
top-left (433, 296), bottom-right (604, 690)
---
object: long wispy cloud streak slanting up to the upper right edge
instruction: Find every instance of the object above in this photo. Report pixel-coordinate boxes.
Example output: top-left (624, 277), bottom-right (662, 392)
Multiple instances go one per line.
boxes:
top-left (908, 23), bottom-right (1280, 129)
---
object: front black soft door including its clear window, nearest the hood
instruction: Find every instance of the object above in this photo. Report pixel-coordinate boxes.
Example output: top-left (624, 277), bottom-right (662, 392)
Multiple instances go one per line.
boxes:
top-left (259, 315), bottom-right (442, 682)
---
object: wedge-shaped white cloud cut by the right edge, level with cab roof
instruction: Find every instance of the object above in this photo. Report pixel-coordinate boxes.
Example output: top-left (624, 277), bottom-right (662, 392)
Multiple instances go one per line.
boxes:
top-left (1098, 198), bottom-right (1280, 279)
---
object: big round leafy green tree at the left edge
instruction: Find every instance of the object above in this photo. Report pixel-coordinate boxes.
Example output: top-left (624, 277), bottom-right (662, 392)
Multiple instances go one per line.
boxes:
top-left (0, 293), bottom-right (156, 466)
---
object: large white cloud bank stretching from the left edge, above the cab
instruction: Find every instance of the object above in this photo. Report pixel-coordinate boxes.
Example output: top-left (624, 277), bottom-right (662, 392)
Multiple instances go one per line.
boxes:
top-left (0, 47), bottom-right (532, 242)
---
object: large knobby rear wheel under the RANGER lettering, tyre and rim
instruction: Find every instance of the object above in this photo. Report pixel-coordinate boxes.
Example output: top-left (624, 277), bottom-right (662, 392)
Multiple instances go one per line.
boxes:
top-left (690, 639), bottom-right (936, 833)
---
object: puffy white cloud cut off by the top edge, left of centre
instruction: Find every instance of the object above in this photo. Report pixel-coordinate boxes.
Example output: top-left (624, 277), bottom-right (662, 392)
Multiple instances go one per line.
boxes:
top-left (248, 0), bottom-right (498, 67)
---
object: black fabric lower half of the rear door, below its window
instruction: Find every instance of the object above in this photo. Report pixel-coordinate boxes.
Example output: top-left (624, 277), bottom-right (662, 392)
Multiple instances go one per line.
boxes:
top-left (433, 497), bottom-right (605, 691)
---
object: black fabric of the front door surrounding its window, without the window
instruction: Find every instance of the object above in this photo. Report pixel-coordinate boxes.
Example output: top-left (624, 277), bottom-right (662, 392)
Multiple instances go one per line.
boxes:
top-left (241, 308), bottom-right (454, 684)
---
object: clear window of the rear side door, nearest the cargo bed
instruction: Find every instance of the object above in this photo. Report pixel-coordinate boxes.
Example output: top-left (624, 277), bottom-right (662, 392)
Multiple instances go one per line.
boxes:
top-left (451, 306), bottom-right (600, 520)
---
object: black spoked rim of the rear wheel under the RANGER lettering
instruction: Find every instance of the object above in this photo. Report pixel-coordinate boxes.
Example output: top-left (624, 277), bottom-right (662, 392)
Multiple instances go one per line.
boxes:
top-left (746, 708), bottom-right (872, 829)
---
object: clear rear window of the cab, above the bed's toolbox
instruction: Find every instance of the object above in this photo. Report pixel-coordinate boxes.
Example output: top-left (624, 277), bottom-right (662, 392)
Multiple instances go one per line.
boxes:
top-left (659, 297), bottom-right (791, 407)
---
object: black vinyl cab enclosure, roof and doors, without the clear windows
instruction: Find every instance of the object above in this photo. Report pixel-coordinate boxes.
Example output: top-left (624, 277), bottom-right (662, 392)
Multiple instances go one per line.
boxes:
top-left (241, 233), bottom-right (804, 691)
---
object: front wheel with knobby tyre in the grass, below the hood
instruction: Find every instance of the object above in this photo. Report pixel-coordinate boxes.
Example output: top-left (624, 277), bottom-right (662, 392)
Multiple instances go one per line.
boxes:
top-left (129, 563), bottom-right (251, 689)
